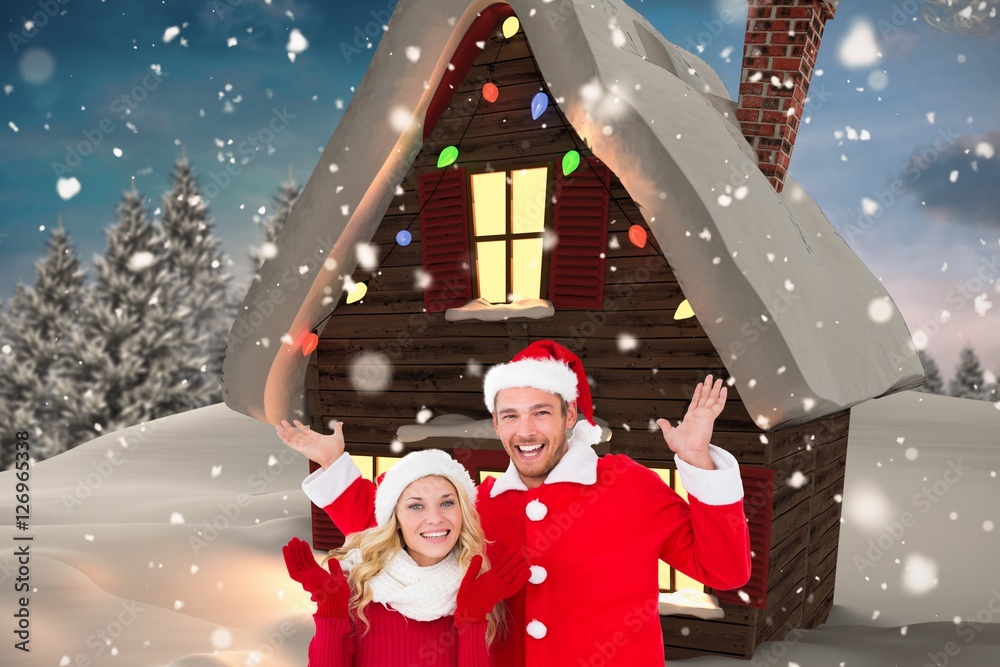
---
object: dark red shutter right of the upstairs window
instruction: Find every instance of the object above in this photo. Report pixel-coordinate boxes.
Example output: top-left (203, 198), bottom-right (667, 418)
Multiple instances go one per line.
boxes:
top-left (549, 156), bottom-right (611, 310)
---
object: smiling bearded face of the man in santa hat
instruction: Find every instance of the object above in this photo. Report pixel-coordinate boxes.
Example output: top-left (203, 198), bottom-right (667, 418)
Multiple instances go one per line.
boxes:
top-left (493, 387), bottom-right (576, 489)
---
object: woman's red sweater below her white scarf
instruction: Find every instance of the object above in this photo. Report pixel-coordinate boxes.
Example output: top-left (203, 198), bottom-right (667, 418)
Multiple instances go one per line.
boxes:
top-left (309, 602), bottom-right (490, 667)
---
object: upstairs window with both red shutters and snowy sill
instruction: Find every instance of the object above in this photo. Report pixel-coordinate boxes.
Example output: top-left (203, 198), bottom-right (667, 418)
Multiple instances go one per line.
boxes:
top-left (418, 156), bottom-right (611, 319)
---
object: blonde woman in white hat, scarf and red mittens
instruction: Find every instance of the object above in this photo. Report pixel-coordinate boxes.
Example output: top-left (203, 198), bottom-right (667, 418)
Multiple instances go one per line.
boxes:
top-left (282, 450), bottom-right (529, 667)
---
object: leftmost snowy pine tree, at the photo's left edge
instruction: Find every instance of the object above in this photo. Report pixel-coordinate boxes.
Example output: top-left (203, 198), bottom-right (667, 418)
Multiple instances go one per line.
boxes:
top-left (0, 223), bottom-right (85, 463)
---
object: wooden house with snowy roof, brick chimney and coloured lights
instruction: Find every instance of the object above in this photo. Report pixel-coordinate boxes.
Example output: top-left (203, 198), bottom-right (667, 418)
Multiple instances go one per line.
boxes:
top-left (224, 0), bottom-right (923, 657)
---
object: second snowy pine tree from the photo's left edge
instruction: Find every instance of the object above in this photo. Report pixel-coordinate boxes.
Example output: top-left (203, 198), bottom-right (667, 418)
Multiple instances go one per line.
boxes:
top-left (57, 189), bottom-right (208, 442)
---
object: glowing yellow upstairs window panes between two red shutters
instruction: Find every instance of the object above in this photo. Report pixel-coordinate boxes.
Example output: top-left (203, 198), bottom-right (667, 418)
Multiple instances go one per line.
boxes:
top-left (470, 167), bottom-right (549, 303)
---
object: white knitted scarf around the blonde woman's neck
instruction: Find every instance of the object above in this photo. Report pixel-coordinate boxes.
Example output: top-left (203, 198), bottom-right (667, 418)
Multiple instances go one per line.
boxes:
top-left (340, 549), bottom-right (462, 621)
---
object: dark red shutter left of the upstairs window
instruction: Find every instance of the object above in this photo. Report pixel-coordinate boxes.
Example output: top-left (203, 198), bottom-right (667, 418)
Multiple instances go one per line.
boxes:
top-left (419, 168), bottom-right (472, 313)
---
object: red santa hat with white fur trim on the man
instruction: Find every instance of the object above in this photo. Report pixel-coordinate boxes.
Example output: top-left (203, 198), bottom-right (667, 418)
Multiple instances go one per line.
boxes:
top-left (483, 340), bottom-right (601, 443)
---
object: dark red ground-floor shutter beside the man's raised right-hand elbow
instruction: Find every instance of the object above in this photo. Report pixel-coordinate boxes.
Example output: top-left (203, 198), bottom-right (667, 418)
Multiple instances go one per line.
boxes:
top-left (713, 466), bottom-right (774, 609)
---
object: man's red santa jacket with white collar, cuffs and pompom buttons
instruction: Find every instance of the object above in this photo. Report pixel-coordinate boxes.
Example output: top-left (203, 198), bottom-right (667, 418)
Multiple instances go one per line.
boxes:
top-left (302, 444), bottom-right (750, 667)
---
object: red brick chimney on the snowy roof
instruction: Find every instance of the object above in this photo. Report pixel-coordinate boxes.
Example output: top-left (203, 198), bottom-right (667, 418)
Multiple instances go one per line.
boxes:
top-left (736, 0), bottom-right (840, 192)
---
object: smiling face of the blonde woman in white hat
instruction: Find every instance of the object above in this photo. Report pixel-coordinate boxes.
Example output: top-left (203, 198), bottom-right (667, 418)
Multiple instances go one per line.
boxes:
top-left (396, 475), bottom-right (462, 567)
